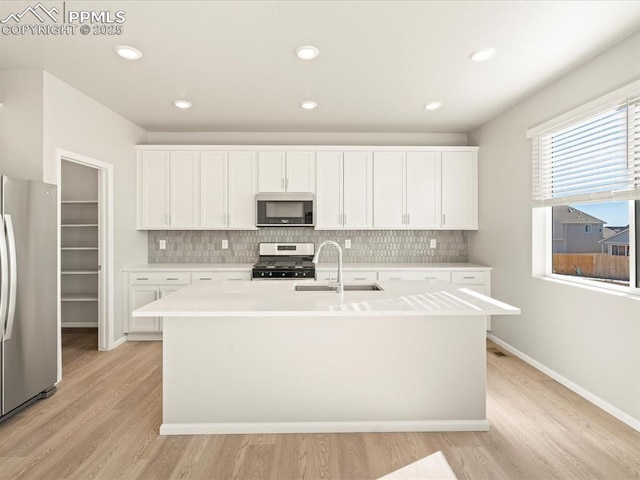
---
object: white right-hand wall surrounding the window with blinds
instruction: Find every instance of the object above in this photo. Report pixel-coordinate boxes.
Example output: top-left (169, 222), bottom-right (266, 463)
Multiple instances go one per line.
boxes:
top-left (468, 32), bottom-right (640, 428)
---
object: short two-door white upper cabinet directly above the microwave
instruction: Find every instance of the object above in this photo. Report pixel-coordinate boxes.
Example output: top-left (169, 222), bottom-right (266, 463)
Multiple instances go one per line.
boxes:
top-left (258, 151), bottom-right (315, 193)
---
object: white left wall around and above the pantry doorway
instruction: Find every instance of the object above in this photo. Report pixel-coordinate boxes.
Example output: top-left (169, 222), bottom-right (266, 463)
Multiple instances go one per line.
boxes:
top-left (41, 72), bottom-right (147, 340)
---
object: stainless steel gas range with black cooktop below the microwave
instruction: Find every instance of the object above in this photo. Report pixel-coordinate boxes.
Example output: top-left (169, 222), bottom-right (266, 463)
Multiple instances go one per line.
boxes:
top-left (252, 243), bottom-right (316, 280)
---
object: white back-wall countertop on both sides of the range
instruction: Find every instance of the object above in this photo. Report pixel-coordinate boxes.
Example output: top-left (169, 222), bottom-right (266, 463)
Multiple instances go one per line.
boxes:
top-left (123, 259), bottom-right (491, 272)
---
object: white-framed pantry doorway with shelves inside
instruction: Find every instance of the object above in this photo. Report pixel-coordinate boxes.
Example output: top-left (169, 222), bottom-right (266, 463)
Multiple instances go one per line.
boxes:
top-left (58, 149), bottom-right (117, 372)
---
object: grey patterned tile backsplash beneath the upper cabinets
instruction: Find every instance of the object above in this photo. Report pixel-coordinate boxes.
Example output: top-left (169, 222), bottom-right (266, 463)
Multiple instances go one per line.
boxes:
top-left (148, 227), bottom-right (467, 263)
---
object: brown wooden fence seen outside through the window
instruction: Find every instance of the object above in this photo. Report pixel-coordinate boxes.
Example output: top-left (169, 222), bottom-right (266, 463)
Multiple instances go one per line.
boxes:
top-left (553, 253), bottom-right (629, 281)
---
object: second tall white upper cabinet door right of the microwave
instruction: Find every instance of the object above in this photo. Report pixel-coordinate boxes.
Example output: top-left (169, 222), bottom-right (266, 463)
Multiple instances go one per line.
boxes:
top-left (342, 152), bottom-right (373, 229)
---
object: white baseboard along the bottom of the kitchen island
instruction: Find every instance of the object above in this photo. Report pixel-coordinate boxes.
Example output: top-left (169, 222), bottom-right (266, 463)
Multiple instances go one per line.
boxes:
top-left (160, 420), bottom-right (489, 435)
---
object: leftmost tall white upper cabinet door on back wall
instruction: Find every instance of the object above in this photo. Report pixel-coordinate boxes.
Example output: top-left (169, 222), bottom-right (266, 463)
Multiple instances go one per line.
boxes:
top-left (138, 151), bottom-right (170, 229)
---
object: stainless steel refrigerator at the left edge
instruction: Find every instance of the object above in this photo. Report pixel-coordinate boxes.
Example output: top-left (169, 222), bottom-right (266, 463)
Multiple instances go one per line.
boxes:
top-left (0, 175), bottom-right (58, 421)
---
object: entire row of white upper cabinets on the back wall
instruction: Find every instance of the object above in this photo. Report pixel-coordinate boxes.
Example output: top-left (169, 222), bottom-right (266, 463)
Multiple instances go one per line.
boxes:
top-left (138, 146), bottom-right (478, 230)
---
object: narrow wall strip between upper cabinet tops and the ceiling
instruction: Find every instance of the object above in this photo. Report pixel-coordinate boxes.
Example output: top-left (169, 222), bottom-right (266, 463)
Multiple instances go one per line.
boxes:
top-left (148, 132), bottom-right (467, 146)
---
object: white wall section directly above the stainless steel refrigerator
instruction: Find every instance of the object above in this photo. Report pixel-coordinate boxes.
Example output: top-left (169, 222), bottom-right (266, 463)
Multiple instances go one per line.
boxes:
top-left (0, 70), bottom-right (43, 182)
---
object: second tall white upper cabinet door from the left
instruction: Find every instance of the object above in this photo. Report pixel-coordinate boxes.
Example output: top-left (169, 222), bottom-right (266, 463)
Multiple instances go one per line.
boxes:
top-left (170, 152), bottom-right (200, 228)
